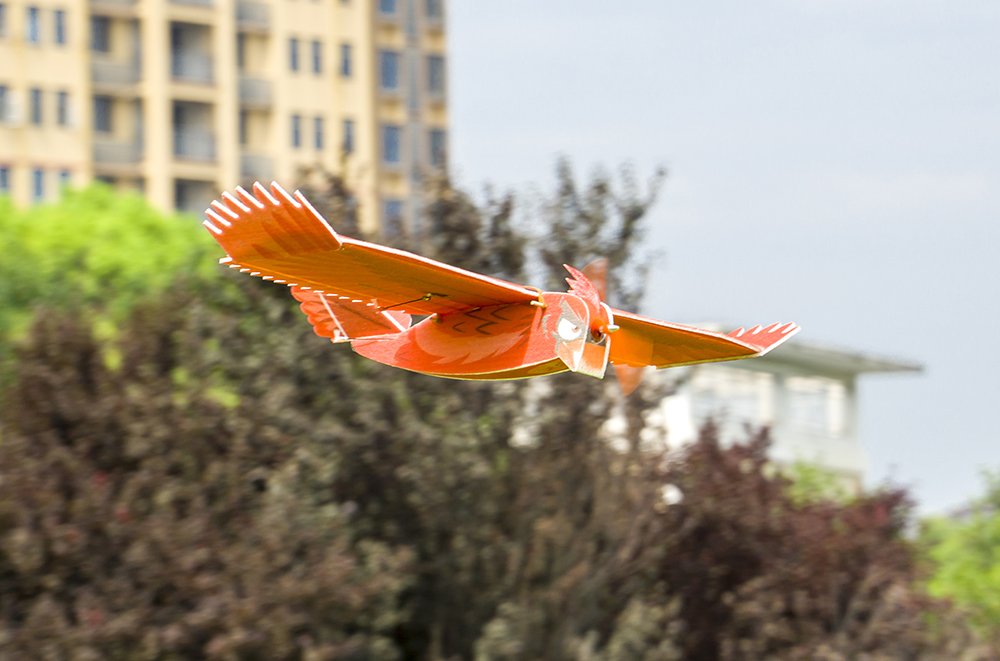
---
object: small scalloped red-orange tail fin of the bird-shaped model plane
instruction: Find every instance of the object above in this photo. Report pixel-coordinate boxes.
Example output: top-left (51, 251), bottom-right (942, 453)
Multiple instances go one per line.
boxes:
top-left (292, 287), bottom-right (411, 342)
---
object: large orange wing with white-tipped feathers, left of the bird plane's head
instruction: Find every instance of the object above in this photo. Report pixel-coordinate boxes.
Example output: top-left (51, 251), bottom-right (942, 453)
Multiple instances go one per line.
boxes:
top-left (205, 183), bottom-right (538, 314)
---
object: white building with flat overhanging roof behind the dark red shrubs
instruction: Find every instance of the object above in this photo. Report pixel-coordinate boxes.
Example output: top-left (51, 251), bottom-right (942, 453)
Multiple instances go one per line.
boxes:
top-left (624, 332), bottom-right (923, 491)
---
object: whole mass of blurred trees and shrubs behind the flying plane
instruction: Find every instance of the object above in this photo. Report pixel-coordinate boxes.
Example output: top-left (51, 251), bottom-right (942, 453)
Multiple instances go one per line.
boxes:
top-left (0, 173), bottom-right (1000, 661)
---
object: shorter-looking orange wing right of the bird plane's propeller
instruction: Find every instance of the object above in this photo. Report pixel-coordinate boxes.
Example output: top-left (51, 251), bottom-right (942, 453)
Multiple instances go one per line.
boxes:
top-left (609, 310), bottom-right (799, 367)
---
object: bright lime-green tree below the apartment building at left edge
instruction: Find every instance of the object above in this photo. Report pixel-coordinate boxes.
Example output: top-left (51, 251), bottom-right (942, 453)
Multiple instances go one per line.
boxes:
top-left (0, 184), bottom-right (217, 342)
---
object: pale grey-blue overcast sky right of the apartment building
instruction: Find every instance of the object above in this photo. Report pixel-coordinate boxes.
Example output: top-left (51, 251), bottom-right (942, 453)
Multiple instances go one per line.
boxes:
top-left (448, 0), bottom-right (1000, 512)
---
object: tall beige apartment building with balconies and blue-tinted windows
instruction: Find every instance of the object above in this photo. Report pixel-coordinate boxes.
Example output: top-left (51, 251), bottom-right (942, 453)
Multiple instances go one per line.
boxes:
top-left (0, 0), bottom-right (447, 232)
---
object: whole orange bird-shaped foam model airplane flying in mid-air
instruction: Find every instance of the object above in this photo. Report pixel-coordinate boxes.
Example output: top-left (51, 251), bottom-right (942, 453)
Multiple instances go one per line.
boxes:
top-left (204, 183), bottom-right (799, 394)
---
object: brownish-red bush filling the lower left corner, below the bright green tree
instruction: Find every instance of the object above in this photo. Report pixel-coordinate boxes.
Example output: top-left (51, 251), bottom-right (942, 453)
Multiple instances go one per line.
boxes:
top-left (0, 301), bottom-right (409, 659)
